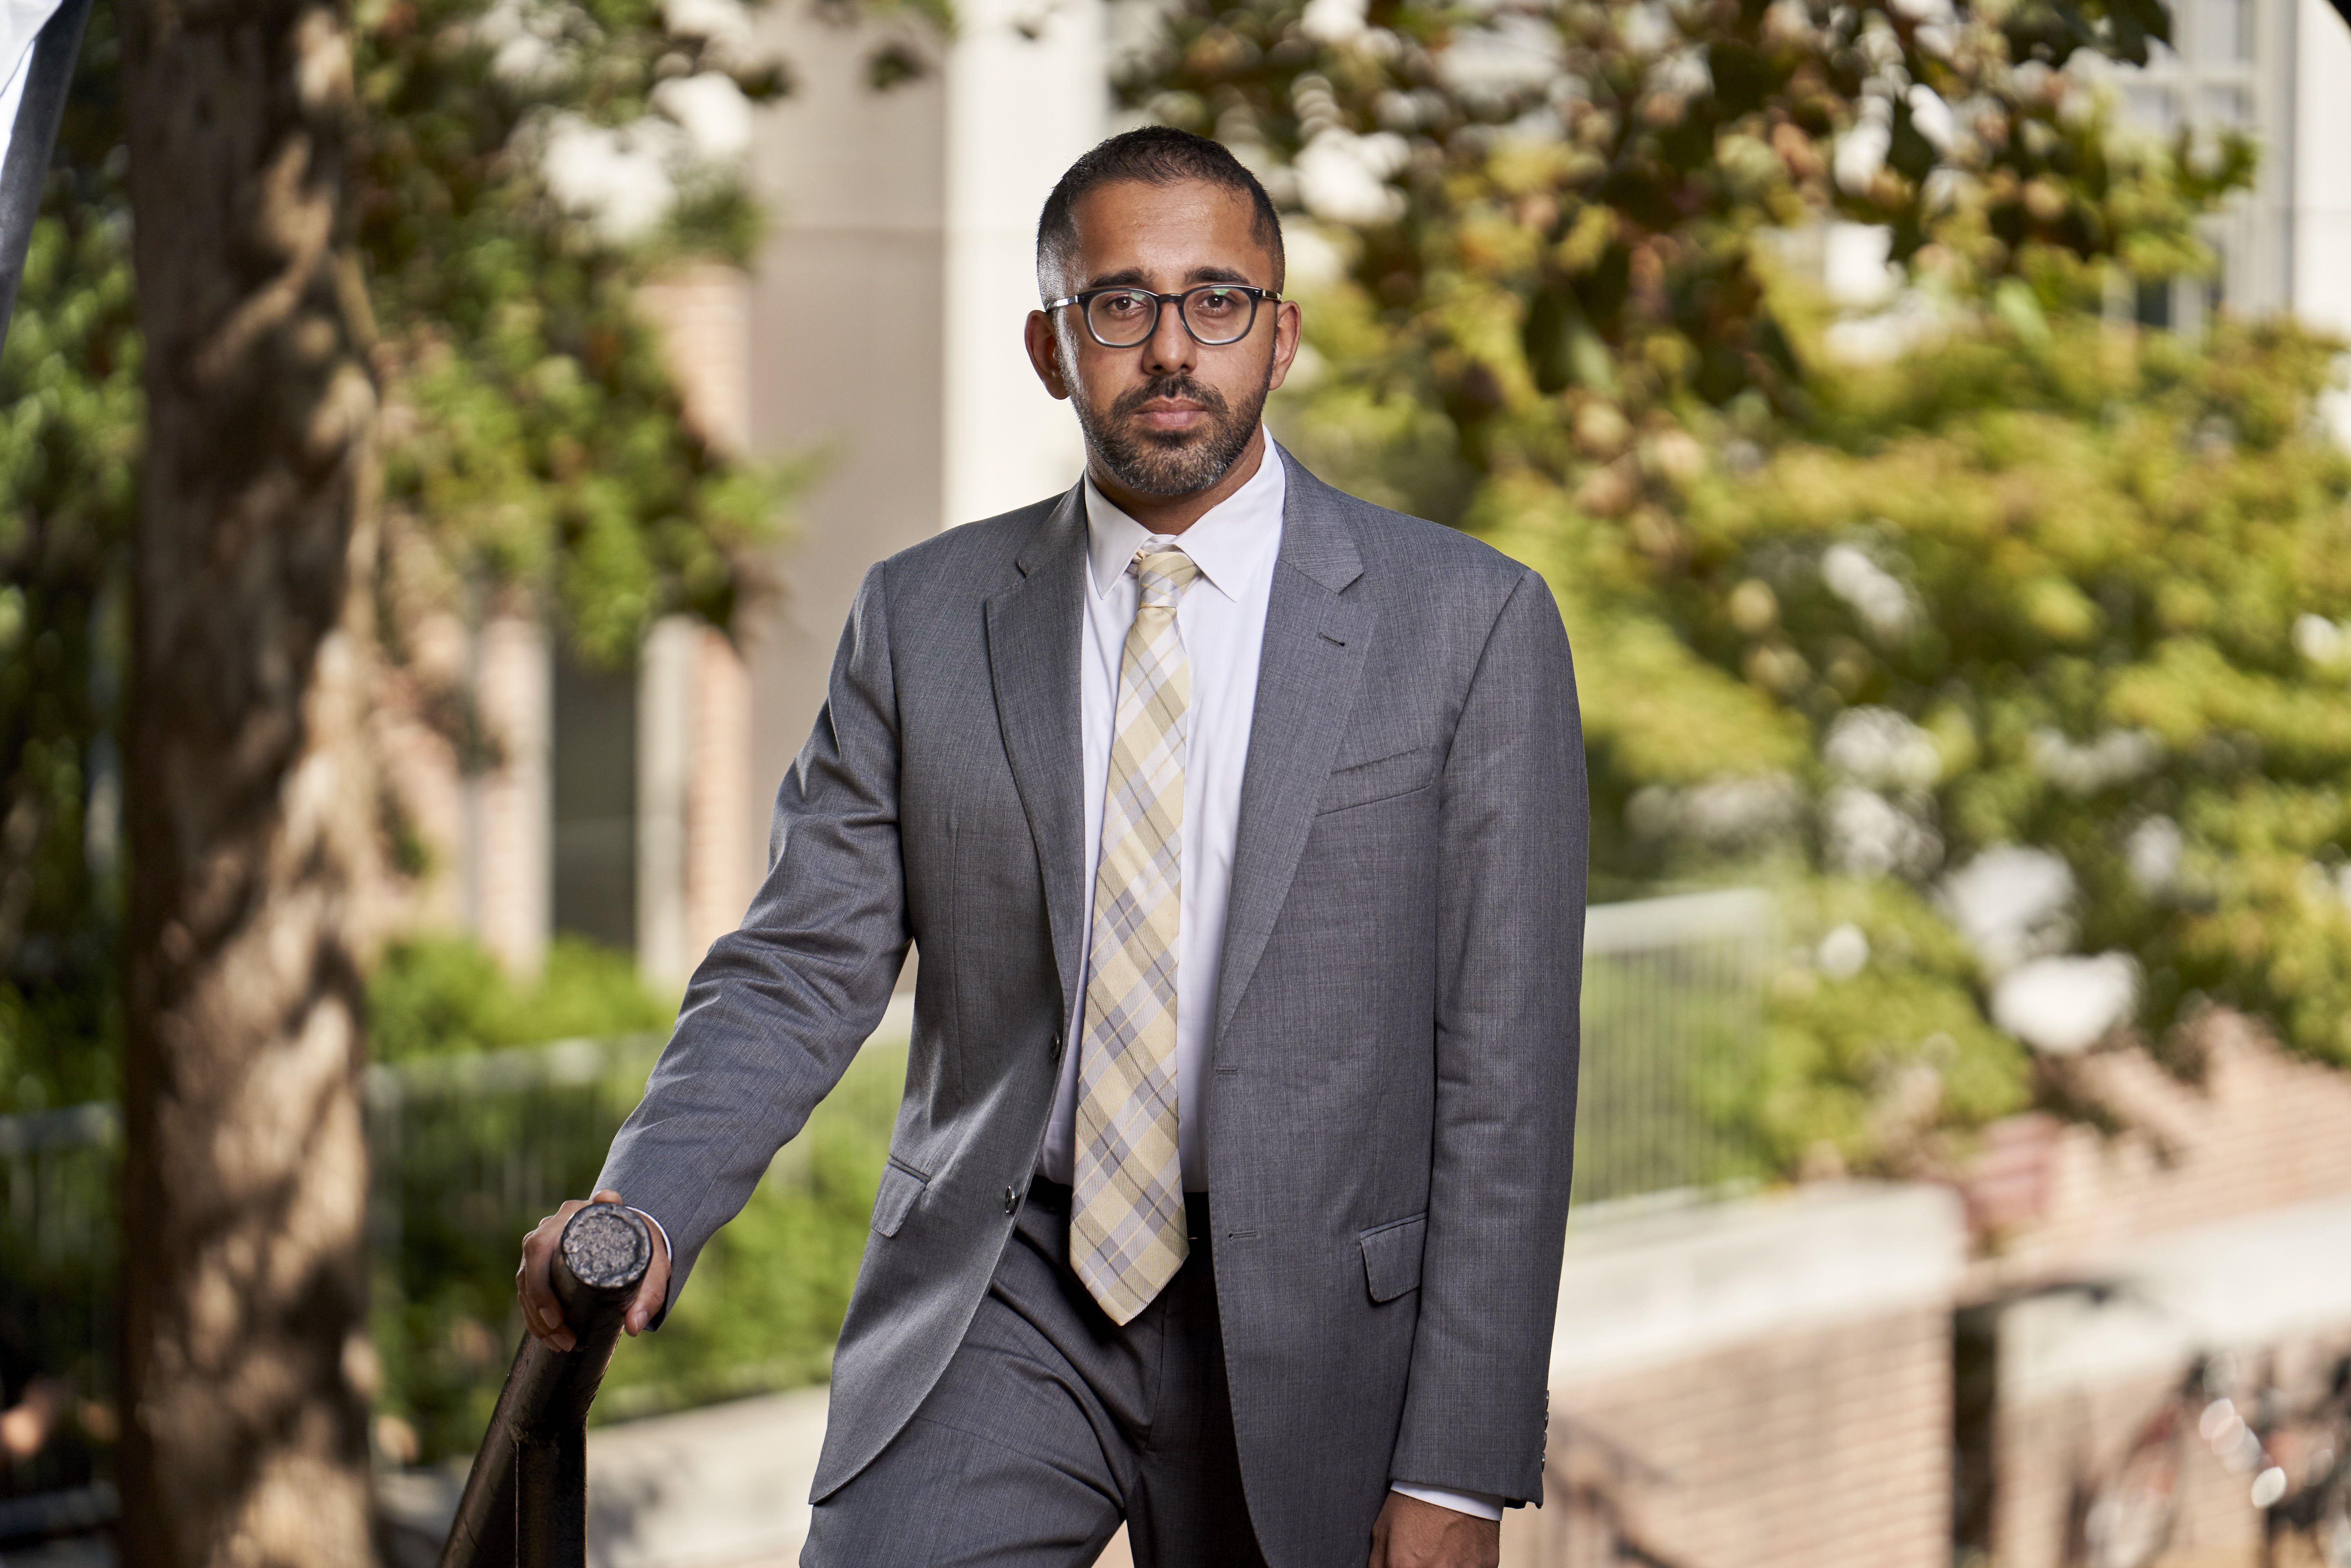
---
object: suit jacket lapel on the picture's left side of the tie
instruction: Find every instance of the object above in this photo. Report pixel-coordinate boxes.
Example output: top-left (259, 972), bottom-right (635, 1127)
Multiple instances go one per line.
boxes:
top-left (987, 487), bottom-right (1086, 1030)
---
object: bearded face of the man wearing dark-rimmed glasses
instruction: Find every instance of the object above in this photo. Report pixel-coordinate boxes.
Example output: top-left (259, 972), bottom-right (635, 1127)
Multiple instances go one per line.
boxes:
top-left (1030, 181), bottom-right (1298, 496)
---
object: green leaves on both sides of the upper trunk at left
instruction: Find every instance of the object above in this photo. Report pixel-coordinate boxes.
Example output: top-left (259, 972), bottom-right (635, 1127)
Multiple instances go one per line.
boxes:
top-left (0, 0), bottom-right (832, 1110)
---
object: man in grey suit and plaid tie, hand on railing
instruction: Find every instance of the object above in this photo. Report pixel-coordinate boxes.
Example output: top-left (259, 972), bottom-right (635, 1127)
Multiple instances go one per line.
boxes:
top-left (520, 129), bottom-right (1587, 1568)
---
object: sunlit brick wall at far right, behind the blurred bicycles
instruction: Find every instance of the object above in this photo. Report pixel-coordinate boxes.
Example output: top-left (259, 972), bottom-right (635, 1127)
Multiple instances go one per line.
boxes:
top-left (1963, 1016), bottom-right (2351, 1568)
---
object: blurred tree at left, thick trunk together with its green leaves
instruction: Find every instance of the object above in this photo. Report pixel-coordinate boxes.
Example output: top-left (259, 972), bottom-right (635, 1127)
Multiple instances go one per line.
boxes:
top-left (0, 0), bottom-right (945, 1561)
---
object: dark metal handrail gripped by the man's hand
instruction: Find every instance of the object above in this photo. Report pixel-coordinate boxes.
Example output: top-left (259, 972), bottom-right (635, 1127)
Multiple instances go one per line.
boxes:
top-left (440, 1204), bottom-right (654, 1568)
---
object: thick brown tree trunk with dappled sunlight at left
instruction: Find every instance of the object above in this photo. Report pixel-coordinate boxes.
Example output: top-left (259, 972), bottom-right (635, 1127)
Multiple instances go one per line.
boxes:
top-left (122, 0), bottom-right (376, 1568)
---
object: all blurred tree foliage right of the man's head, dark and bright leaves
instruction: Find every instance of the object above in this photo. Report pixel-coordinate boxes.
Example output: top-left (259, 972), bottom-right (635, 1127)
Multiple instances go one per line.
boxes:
top-left (1124, 0), bottom-right (2351, 1171)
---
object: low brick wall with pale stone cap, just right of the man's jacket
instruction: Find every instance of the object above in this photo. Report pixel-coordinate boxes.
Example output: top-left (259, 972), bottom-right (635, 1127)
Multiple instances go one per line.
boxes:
top-left (1502, 1182), bottom-right (1963, 1568)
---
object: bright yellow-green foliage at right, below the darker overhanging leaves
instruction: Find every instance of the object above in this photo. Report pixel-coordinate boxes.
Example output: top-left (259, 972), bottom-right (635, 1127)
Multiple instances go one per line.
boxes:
top-left (1505, 317), bottom-right (2351, 1164)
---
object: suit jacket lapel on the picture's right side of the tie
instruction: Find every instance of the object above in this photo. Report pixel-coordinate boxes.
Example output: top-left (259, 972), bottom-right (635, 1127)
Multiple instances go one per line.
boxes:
top-left (1215, 451), bottom-right (1373, 1039)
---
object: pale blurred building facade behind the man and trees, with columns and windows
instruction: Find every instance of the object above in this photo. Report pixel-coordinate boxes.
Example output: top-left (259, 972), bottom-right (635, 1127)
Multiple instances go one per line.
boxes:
top-left (437, 0), bottom-right (2351, 985)
